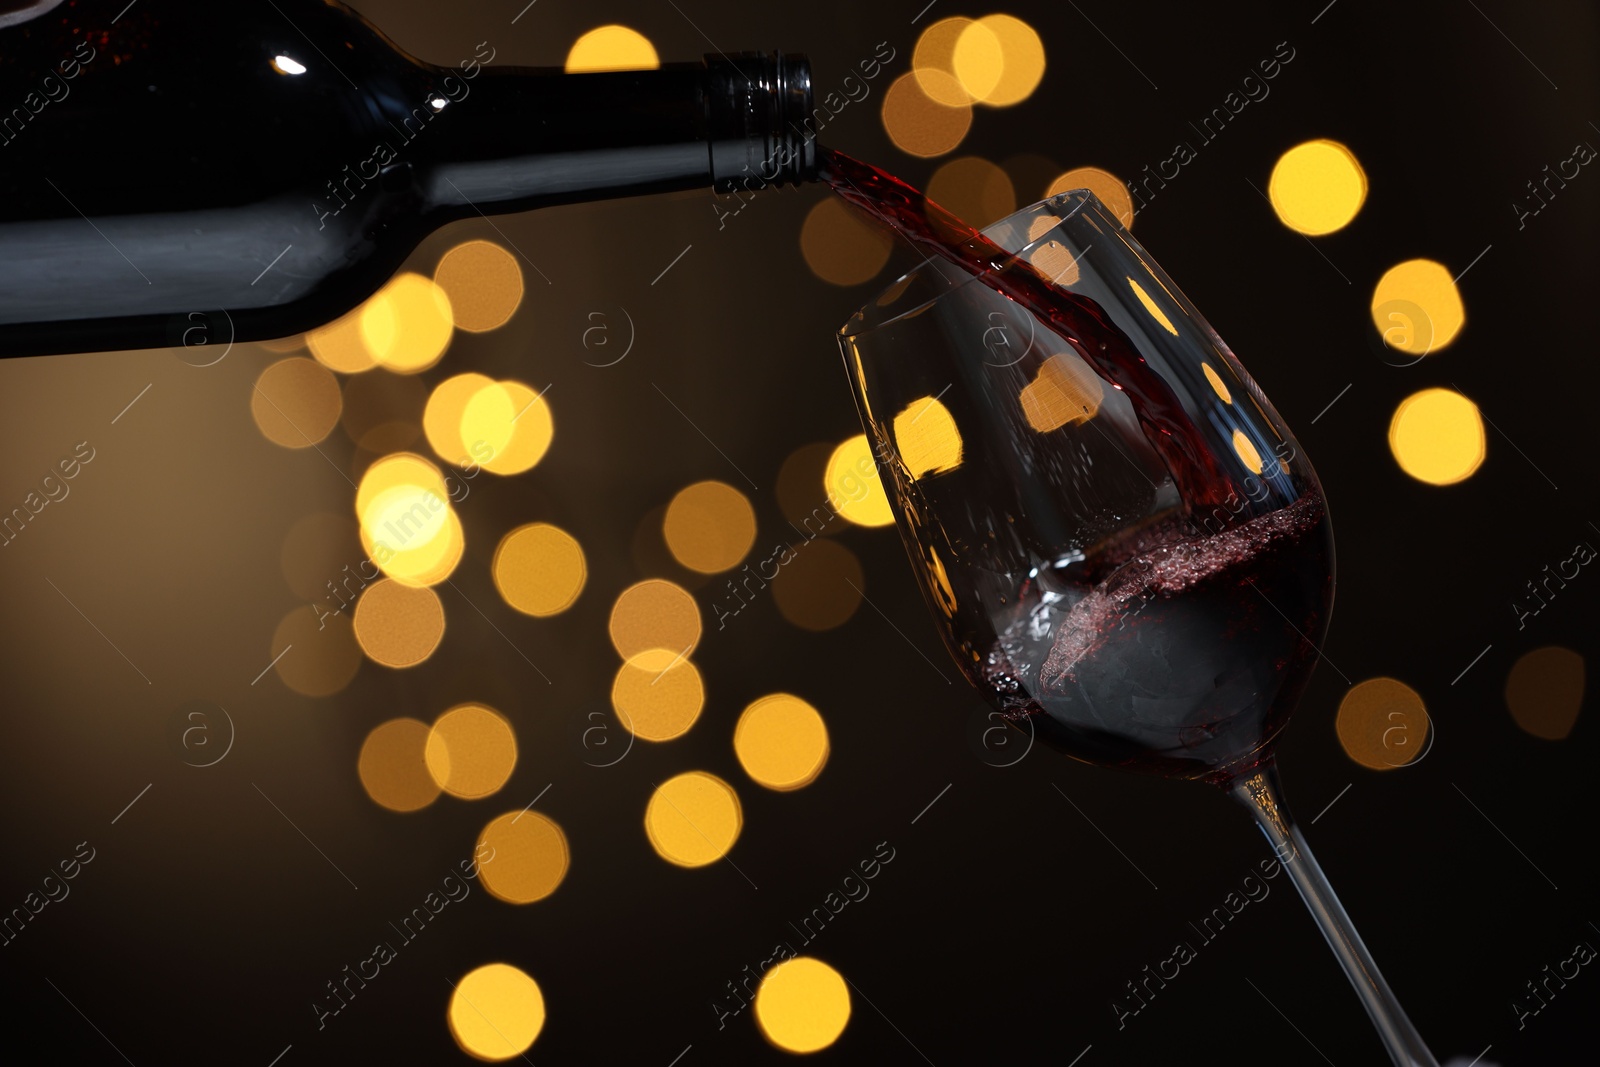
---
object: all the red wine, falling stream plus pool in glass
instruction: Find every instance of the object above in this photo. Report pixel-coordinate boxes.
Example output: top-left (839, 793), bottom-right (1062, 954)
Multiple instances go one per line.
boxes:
top-left (821, 150), bottom-right (1333, 784)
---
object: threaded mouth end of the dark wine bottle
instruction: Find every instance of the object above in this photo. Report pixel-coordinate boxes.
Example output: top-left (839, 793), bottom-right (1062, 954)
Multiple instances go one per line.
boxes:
top-left (706, 51), bottom-right (818, 192)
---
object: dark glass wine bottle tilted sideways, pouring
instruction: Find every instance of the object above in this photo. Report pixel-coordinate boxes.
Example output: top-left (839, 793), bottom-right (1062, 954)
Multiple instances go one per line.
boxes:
top-left (0, 0), bottom-right (816, 357)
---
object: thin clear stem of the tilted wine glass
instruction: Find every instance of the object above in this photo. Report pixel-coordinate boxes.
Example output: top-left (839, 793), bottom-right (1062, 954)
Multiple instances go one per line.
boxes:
top-left (1230, 765), bottom-right (1438, 1067)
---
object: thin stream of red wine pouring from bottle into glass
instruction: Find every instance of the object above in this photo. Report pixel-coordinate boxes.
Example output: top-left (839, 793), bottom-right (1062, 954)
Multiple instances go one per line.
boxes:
top-left (818, 149), bottom-right (1242, 512)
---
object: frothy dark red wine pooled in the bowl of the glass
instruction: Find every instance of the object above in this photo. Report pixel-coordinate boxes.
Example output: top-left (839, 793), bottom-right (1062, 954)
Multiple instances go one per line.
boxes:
top-left (968, 493), bottom-right (1331, 781)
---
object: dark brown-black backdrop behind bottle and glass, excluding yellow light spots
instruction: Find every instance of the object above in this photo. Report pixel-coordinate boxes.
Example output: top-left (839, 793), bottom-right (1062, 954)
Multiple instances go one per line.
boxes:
top-left (0, 0), bottom-right (1600, 1067)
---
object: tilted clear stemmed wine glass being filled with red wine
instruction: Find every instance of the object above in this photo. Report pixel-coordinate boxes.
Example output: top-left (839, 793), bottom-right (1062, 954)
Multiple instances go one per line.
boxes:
top-left (840, 190), bottom-right (1435, 1067)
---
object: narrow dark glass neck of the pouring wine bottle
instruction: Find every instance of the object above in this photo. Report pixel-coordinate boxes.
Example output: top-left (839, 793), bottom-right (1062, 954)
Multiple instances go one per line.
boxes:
top-left (416, 53), bottom-right (816, 214)
